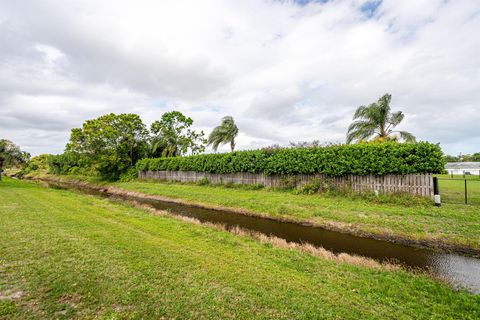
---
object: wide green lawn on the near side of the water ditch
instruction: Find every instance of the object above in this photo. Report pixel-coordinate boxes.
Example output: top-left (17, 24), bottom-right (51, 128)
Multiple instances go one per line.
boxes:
top-left (0, 179), bottom-right (480, 319)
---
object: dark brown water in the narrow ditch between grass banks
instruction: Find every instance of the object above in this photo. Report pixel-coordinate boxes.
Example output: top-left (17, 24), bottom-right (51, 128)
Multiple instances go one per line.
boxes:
top-left (45, 183), bottom-right (480, 294)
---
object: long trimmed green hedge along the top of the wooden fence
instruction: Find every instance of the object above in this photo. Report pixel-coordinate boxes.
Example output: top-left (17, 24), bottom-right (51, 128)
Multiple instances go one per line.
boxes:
top-left (137, 142), bottom-right (444, 176)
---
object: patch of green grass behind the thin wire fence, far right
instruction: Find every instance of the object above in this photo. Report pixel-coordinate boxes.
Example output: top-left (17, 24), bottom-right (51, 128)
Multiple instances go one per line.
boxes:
top-left (436, 174), bottom-right (480, 205)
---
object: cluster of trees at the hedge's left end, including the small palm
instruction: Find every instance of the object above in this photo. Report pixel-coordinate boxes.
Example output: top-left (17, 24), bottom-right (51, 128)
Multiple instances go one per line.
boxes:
top-left (42, 111), bottom-right (238, 180)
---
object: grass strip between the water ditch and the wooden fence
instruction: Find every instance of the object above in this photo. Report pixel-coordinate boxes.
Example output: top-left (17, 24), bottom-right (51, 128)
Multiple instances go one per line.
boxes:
top-left (114, 181), bottom-right (480, 250)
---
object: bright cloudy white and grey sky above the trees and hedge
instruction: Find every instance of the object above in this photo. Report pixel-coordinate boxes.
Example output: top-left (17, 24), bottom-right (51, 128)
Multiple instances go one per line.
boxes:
top-left (0, 0), bottom-right (480, 154)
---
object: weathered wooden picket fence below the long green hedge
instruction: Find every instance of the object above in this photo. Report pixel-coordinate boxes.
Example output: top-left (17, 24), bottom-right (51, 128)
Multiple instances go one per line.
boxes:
top-left (139, 171), bottom-right (433, 198)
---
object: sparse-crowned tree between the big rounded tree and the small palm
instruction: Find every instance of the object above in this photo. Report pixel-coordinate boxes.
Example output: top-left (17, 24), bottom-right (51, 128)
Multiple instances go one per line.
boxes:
top-left (150, 111), bottom-right (206, 157)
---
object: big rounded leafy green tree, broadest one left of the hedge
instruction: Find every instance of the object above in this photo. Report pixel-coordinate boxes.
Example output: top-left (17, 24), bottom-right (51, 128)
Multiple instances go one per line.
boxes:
top-left (65, 113), bottom-right (148, 180)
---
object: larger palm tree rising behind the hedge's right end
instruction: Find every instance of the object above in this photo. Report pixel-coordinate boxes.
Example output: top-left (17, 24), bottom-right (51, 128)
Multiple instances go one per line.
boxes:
top-left (347, 93), bottom-right (415, 143)
